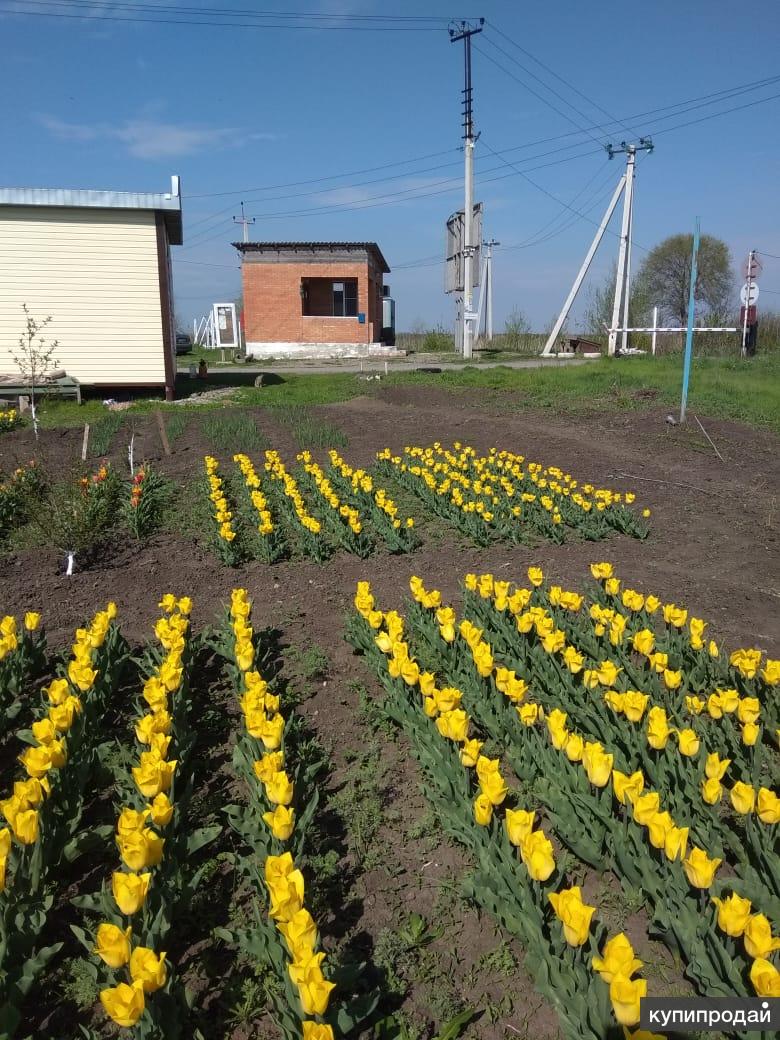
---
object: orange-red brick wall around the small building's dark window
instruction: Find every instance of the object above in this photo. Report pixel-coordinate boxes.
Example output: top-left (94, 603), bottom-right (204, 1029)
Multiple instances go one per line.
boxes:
top-left (241, 261), bottom-right (382, 343)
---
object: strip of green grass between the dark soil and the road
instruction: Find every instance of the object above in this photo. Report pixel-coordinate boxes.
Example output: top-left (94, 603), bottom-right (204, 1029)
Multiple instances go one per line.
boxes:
top-left (28, 353), bottom-right (780, 436)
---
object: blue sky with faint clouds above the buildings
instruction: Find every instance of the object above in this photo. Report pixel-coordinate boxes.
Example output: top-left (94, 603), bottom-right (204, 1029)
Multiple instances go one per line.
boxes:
top-left (0, 0), bottom-right (780, 329)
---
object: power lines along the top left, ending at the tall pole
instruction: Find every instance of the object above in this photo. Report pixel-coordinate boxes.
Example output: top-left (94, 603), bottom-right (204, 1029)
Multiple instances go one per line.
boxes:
top-left (0, 0), bottom-right (448, 32)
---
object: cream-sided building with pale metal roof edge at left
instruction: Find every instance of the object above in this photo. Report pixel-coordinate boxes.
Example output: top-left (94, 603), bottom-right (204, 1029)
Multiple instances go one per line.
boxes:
top-left (0, 177), bottom-right (182, 399)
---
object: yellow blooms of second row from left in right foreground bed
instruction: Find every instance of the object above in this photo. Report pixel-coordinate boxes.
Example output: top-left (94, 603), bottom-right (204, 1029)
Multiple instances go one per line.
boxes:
top-left (406, 573), bottom-right (780, 996)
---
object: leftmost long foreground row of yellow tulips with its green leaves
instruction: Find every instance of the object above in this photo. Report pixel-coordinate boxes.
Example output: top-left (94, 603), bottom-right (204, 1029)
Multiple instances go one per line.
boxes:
top-left (0, 603), bottom-right (127, 1035)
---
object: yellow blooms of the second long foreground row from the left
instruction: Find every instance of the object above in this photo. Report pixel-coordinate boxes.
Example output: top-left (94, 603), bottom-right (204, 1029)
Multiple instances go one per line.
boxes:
top-left (88, 594), bottom-right (192, 1029)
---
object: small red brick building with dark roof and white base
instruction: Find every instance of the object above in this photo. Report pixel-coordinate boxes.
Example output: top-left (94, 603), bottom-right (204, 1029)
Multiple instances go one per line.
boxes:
top-left (234, 242), bottom-right (397, 358)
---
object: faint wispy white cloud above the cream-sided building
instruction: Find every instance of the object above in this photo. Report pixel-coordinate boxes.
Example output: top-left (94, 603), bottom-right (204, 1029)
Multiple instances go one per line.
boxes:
top-left (40, 115), bottom-right (274, 159)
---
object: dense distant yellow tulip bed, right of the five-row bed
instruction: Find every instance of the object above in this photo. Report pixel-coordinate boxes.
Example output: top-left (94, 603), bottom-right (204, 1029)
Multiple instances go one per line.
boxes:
top-left (376, 441), bottom-right (650, 546)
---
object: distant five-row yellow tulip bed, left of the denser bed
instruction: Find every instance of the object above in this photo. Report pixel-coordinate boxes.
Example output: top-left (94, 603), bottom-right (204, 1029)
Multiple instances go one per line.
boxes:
top-left (203, 450), bottom-right (418, 567)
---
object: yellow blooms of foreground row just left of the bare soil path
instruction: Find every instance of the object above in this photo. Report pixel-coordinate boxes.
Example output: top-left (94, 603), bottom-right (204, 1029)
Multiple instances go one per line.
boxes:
top-left (230, 589), bottom-right (334, 1040)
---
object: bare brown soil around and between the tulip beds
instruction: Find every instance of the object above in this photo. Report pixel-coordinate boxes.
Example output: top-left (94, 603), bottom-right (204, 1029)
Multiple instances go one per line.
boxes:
top-left (0, 388), bottom-right (780, 1040)
